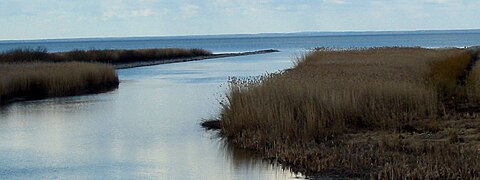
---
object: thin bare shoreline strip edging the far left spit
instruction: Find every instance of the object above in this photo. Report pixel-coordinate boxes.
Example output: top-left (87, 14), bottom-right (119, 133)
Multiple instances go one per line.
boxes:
top-left (112, 49), bottom-right (280, 69)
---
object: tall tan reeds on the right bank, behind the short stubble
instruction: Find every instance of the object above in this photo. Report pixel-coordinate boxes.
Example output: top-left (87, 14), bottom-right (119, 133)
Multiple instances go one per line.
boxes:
top-left (222, 48), bottom-right (460, 143)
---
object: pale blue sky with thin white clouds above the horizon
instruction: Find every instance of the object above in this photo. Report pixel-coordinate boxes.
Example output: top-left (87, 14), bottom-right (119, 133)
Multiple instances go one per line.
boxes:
top-left (0, 0), bottom-right (480, 40)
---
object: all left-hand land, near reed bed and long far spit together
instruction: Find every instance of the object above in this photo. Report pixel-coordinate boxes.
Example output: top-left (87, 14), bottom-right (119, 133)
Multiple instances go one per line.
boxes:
top-left (0, 48), bottom-right (278, 105)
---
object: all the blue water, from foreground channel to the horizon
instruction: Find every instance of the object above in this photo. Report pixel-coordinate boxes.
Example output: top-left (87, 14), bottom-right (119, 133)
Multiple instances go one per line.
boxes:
top-left (0, 34), bottom-right (480, 179)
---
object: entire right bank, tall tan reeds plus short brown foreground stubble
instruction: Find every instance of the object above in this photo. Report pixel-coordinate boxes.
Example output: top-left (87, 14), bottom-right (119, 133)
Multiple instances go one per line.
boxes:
top-left (212, 48), bottom-right (480, 179)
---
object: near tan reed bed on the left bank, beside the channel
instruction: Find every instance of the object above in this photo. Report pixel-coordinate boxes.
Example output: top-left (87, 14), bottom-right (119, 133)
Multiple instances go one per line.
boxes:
top-left (0, 62), bottom-right (119, 104)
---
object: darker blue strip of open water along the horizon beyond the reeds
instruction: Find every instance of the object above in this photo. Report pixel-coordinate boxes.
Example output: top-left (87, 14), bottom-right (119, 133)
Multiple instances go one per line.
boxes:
top-left (0, 33), bottom-right (480, 52)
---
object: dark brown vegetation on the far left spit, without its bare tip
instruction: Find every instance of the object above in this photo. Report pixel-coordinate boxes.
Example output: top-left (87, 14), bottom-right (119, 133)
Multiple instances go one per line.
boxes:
top-left (0, 48), bottom-right (212, 64)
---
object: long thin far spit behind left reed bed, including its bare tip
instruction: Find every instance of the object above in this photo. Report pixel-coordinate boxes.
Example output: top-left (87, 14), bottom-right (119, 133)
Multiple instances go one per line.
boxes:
top-left (0, 48), bottom-right (279, 69)
